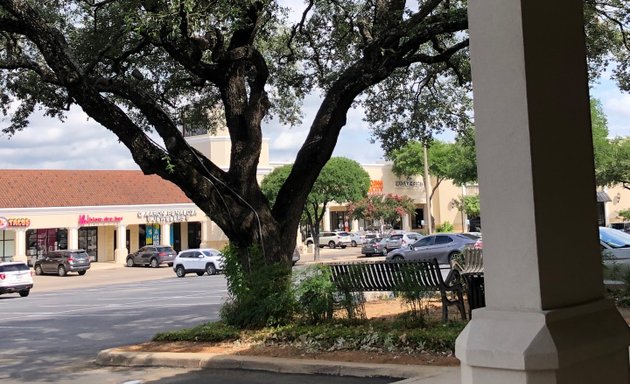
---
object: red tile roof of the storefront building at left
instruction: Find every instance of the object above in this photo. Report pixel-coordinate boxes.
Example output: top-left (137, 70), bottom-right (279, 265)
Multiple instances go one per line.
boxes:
top-left (0, 169), bottom-right (191, 208)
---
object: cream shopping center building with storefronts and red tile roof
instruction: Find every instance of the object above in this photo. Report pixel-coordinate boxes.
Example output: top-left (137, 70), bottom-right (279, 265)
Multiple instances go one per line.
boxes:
top-left (0, 127), bottom-right (630, 263)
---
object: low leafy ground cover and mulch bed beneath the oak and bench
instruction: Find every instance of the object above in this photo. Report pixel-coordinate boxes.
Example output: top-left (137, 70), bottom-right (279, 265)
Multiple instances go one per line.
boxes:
top-left (153, 315), bottom-right (465, 355)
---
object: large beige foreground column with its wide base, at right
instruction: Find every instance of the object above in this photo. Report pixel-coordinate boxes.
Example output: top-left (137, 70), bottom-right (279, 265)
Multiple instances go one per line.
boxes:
top-left (456, 0), bottom-right (630, 384)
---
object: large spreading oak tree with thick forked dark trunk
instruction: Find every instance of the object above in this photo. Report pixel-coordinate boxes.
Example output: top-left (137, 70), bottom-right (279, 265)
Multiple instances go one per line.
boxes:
top-left (0, 0), bottom-right (630, 324)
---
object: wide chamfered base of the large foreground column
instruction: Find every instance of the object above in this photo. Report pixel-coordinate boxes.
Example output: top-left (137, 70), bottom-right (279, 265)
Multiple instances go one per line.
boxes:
top-left (455, 300), bottom-right (630, 384)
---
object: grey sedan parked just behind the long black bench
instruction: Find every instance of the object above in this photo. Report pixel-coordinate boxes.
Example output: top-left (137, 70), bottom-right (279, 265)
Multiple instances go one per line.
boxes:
top-left (385, 233), bottom-right (475, 264)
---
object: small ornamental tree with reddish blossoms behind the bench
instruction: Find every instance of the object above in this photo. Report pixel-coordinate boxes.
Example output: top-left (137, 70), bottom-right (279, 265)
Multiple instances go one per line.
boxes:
top-left (348, 193), bottom-right (416, 229)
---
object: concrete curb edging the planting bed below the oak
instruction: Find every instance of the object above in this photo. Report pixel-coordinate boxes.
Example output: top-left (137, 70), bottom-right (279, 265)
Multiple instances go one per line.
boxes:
top-left (96, 348), bottom-right (459, 382)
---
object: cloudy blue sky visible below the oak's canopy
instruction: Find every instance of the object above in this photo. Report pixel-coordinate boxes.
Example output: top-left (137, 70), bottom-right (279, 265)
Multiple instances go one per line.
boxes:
top-left (0, 80), bottom-right (630, 169)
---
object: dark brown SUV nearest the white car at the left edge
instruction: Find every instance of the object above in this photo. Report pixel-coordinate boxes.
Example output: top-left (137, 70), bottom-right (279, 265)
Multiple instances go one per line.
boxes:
top-left (33, 249), bottom-right (92, 276)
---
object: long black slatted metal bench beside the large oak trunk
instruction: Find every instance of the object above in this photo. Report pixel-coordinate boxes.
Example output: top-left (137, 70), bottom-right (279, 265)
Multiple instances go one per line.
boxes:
top-left (327, 259), bottom-right (466, 322)
